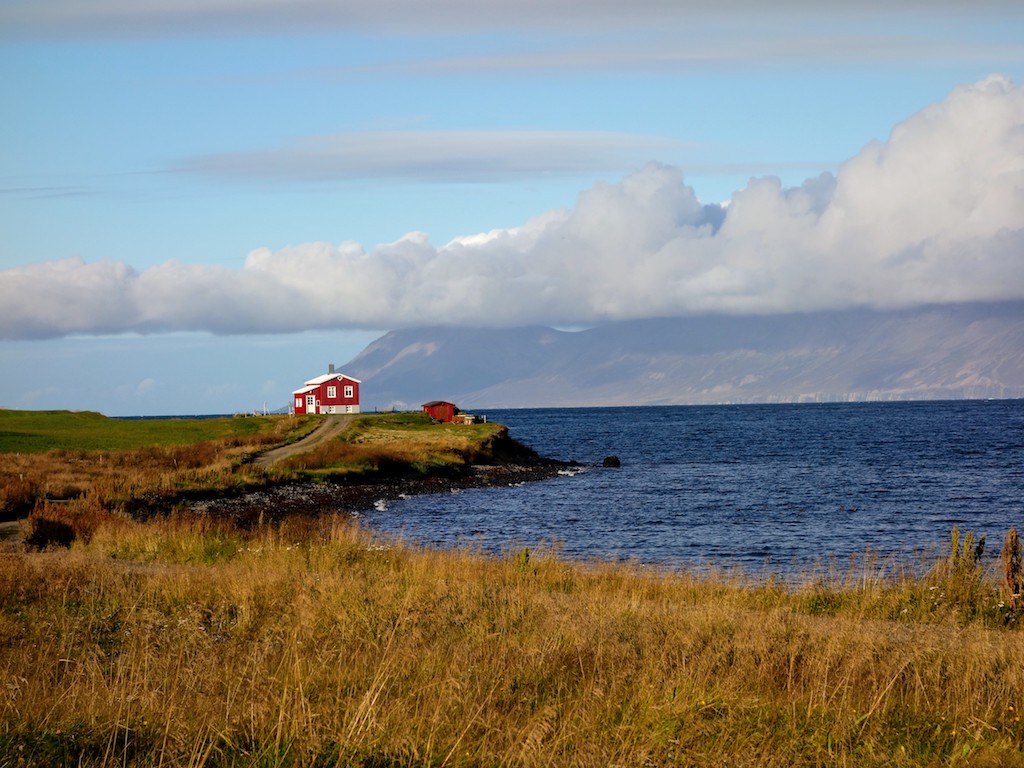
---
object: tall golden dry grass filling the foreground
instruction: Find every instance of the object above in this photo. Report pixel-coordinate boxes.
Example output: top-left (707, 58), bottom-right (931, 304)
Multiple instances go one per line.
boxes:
top-left (0, 516), bottom-right (1024, 766)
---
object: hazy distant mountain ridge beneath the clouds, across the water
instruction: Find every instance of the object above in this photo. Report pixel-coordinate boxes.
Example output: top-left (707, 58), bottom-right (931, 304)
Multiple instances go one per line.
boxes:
top-left (343, 302), bottom-right (1024, 410)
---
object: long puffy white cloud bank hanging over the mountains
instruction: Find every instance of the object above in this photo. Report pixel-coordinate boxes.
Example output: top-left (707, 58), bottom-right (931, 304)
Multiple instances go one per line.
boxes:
top-left (0, 77), bottom-right (1024, 338)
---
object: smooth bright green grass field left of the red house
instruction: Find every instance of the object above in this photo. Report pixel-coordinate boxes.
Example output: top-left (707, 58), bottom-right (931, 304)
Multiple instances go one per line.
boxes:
top-left (0, 410), bottom-right (284, 454)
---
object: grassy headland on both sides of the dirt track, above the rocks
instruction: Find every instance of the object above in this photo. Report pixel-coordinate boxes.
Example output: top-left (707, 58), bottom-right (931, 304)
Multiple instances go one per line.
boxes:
top-left (0, 411), bottom-right (511, 538)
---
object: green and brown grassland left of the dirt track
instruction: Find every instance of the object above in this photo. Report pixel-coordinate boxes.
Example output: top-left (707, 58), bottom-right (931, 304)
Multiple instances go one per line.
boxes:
top-left (0, 411), bottom-right (314, 519)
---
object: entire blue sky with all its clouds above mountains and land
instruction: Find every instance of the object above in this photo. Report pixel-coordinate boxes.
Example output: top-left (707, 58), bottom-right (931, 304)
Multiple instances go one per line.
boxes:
top-left (0, 0), bottom-right (1024, 415)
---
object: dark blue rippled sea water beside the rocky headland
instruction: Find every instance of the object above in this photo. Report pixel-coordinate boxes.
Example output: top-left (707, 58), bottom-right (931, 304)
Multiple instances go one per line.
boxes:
top-left (367, 400), bottom-right (1024, 570)
